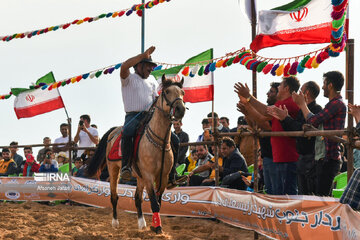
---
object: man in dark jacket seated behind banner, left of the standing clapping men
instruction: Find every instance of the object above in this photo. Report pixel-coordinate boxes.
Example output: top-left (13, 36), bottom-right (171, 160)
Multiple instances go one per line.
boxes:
top-left (220, 137), bottom-right (248, 190)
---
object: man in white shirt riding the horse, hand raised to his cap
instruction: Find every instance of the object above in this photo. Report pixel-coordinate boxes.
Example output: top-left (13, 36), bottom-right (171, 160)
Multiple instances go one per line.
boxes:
top-left (120, 46), bottom-right (186, 188)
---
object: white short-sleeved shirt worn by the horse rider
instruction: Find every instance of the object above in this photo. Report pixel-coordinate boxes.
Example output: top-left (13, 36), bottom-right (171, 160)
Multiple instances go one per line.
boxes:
top-left (121, 73), bottom-right (159, 112)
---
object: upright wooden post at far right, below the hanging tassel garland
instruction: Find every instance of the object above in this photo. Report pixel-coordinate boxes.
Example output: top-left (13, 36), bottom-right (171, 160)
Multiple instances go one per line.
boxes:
top-left (346, 39), bottom-right (355, 181)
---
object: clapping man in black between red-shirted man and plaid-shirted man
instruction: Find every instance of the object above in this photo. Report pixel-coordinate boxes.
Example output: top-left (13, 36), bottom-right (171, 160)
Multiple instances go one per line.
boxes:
top-left (270, 81), bottom-right (322, 195)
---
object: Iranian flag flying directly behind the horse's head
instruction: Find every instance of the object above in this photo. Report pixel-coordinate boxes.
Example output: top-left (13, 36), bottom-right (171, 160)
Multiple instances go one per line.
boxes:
top-left (151, 49), bottom-right (214, 103)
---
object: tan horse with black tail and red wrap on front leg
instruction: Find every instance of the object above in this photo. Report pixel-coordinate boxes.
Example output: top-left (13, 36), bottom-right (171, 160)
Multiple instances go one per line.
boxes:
top-left (88, 76), bottom-right (185, 233)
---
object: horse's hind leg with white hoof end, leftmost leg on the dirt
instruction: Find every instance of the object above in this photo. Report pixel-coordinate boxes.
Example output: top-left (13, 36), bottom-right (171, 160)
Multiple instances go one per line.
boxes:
top-left (108, 162), bottom-right (120, 228)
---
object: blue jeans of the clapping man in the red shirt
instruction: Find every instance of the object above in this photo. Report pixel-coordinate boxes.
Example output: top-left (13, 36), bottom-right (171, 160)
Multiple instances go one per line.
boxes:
top-left (273, 162), bottom-right (297, 195)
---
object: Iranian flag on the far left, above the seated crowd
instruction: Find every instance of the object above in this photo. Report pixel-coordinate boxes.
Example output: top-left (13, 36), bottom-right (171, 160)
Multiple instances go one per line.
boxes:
top-left (11, 72), bottom-right (64, 119)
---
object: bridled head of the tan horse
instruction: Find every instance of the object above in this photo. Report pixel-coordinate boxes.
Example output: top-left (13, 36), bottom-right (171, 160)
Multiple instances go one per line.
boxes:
top-left (161, 74), bottom-right (185, 120)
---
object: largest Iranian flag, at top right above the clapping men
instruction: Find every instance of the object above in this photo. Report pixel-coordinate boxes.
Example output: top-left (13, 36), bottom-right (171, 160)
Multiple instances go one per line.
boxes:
top-left (250, 0), bottom-right (332, 52)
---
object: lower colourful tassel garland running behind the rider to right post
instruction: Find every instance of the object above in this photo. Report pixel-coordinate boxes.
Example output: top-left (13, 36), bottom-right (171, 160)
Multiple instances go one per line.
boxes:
top-left (0, 0), bottom-right (348, 100)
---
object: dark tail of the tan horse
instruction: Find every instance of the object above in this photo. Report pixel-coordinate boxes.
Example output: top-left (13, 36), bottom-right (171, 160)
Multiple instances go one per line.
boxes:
top-left (86, 127), bottom-right (116, 177)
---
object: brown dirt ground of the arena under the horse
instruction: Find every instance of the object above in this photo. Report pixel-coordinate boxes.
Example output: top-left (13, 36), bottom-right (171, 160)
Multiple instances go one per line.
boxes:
top-left (0, 202), bottom-right (266, 240)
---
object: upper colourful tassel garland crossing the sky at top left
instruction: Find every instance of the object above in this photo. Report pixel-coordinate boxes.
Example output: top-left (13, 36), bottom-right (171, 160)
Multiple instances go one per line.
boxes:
top-left (0, 0), bottom-right (171, 42)
